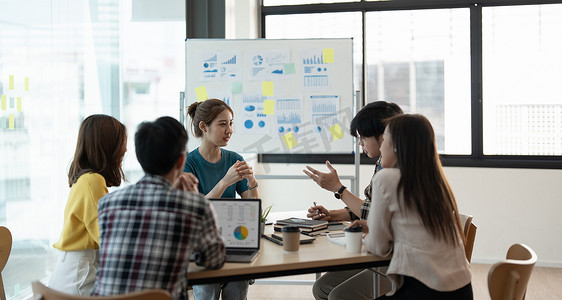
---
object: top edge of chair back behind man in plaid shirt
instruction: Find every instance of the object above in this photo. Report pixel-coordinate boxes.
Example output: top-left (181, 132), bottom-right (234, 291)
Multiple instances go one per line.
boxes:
top-left (31, 281), bottom-right (172, 300)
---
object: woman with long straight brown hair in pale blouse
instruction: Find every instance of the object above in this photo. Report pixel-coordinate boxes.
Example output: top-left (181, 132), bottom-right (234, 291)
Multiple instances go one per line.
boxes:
top-left (354, 115), bottom-right (473, 300)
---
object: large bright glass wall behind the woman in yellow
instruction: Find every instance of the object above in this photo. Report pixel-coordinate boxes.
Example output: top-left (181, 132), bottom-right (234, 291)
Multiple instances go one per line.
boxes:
top-left (0, 0), bottom-right (186, 299)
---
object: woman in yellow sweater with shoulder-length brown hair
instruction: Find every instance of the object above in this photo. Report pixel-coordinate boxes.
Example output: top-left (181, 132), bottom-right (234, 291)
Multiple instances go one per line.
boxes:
top-left (49, 115), bottom-right (127, 295)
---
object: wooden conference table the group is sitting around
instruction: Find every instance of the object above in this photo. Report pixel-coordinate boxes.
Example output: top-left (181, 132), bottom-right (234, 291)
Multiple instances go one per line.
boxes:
top-left (188, 226), bottom-right (390, 285)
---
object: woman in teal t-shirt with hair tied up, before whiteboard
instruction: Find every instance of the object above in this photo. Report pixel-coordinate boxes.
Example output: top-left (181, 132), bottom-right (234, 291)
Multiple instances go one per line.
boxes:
top-left (183, 99), bottom-right (258, 300)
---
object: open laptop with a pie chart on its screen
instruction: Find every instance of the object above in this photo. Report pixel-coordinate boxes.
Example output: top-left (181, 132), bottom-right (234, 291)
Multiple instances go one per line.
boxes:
top-left (209, 198), bottom-right (261, 263)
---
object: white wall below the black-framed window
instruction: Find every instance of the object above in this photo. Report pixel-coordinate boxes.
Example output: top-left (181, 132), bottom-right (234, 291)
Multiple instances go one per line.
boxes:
top-left (255, 164), bottom-right (562, 267)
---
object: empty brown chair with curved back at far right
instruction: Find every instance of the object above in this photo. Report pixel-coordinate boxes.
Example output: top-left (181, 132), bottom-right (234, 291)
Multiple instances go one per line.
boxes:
top-left (488, 244), bottom-right (537, 300)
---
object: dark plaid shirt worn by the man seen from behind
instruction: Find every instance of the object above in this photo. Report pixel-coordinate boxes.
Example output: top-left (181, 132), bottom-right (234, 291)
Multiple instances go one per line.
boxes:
top-left (92, 175), bottom-right (226, 299)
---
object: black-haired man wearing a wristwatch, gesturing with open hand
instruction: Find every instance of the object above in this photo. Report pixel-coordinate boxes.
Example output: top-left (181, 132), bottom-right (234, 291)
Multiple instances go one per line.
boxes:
top-left (303, 101), bottom-right (402, 299)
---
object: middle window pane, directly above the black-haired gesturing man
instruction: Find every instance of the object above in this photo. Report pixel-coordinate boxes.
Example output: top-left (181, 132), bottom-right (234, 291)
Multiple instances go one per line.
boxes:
top-left (365, 8), bottom-right (471, 154)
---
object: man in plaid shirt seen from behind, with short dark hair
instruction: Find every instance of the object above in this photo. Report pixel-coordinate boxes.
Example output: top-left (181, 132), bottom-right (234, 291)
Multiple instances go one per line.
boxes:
top-left (92, 117), bottom-right (226, 299)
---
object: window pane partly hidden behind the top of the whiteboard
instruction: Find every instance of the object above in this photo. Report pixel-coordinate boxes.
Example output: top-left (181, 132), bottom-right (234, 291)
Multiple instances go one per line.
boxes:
top-left (265, 12), bottom-right (363, 110)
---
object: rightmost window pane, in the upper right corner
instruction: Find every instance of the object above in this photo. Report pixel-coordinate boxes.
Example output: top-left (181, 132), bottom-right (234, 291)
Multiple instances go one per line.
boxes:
top-left (482, 4), bottom-right (562, 155)
